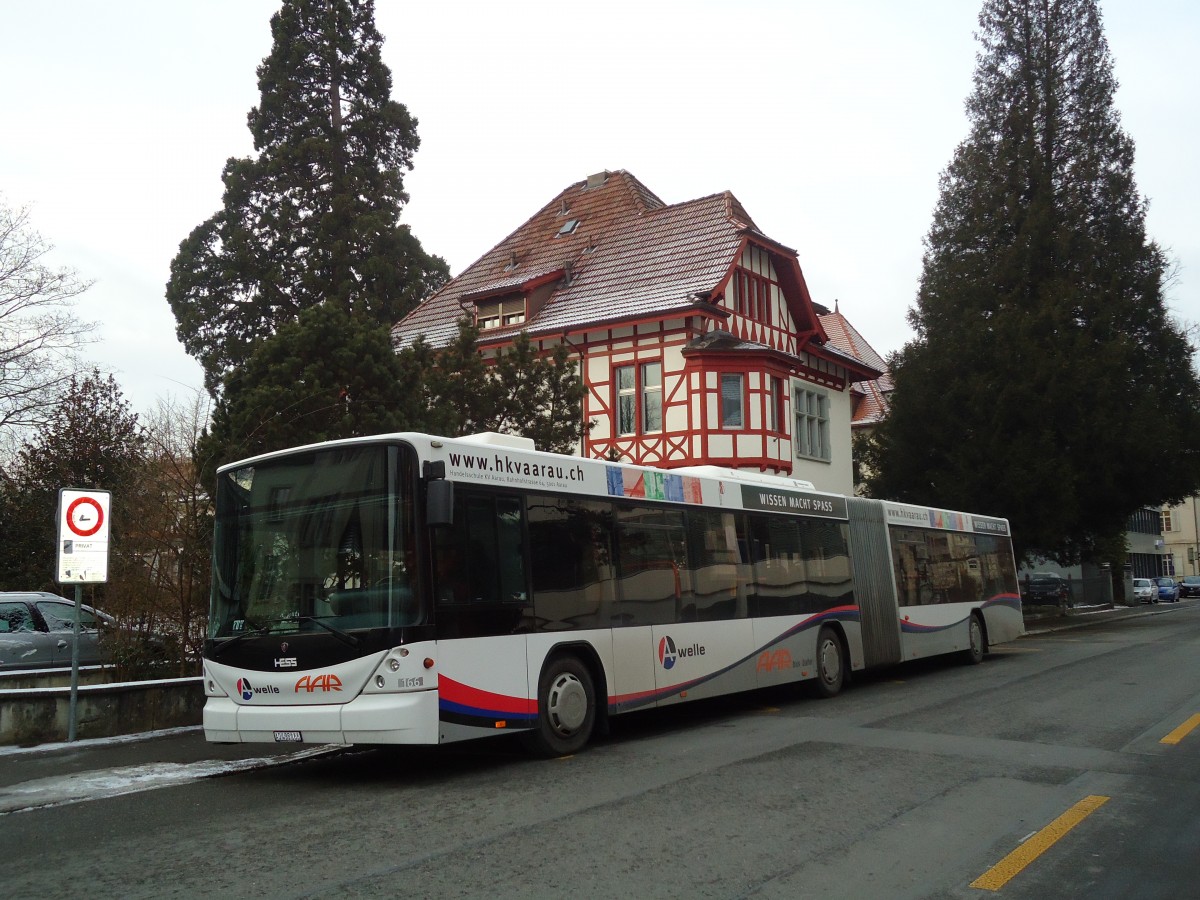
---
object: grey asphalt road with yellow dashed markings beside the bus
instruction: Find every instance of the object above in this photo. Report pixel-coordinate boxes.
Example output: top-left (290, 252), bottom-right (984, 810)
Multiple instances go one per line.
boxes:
top-left (0, 602), bottom-right (1200, 900)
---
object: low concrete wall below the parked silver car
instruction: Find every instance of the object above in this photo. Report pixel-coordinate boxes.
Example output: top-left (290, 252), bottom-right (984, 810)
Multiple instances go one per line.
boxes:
top-left (0, 676), bottom-right (204, 745)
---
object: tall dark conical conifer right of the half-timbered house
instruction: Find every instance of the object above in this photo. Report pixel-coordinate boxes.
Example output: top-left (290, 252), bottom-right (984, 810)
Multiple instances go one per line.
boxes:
top-left (865, 0), bottom-right (1200, 562)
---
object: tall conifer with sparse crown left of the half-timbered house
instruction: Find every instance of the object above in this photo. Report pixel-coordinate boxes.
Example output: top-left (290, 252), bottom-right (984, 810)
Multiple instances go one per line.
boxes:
top-left (167, 0), bottom-right (446, 396)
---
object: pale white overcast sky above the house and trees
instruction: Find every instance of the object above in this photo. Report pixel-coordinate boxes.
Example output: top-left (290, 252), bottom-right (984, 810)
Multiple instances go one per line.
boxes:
top-left (0, 0), bottom-right (1200, 412)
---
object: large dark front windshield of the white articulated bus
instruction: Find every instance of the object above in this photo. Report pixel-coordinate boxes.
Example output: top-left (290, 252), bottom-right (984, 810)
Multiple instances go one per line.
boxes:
top-left (209, 444), bottom-right (425, 641)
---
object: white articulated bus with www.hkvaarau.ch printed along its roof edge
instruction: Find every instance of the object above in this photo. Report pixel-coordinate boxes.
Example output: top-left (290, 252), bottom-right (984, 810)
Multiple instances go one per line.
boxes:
top-left (204, 433), bottom-right (1024, 755)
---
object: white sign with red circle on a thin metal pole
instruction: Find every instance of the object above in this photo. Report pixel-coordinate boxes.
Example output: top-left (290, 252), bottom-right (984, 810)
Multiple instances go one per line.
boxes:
top-left (58, 487), bottom-right (112, 740)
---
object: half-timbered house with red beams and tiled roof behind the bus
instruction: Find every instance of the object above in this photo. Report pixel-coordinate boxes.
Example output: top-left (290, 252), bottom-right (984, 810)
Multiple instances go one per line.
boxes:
top-left (394, 172), bottom-right (880, 493)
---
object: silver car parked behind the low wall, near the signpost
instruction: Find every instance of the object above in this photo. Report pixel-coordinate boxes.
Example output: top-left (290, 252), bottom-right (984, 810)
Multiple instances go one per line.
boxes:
top-left (0, 592), bottom-right (113, 671)
